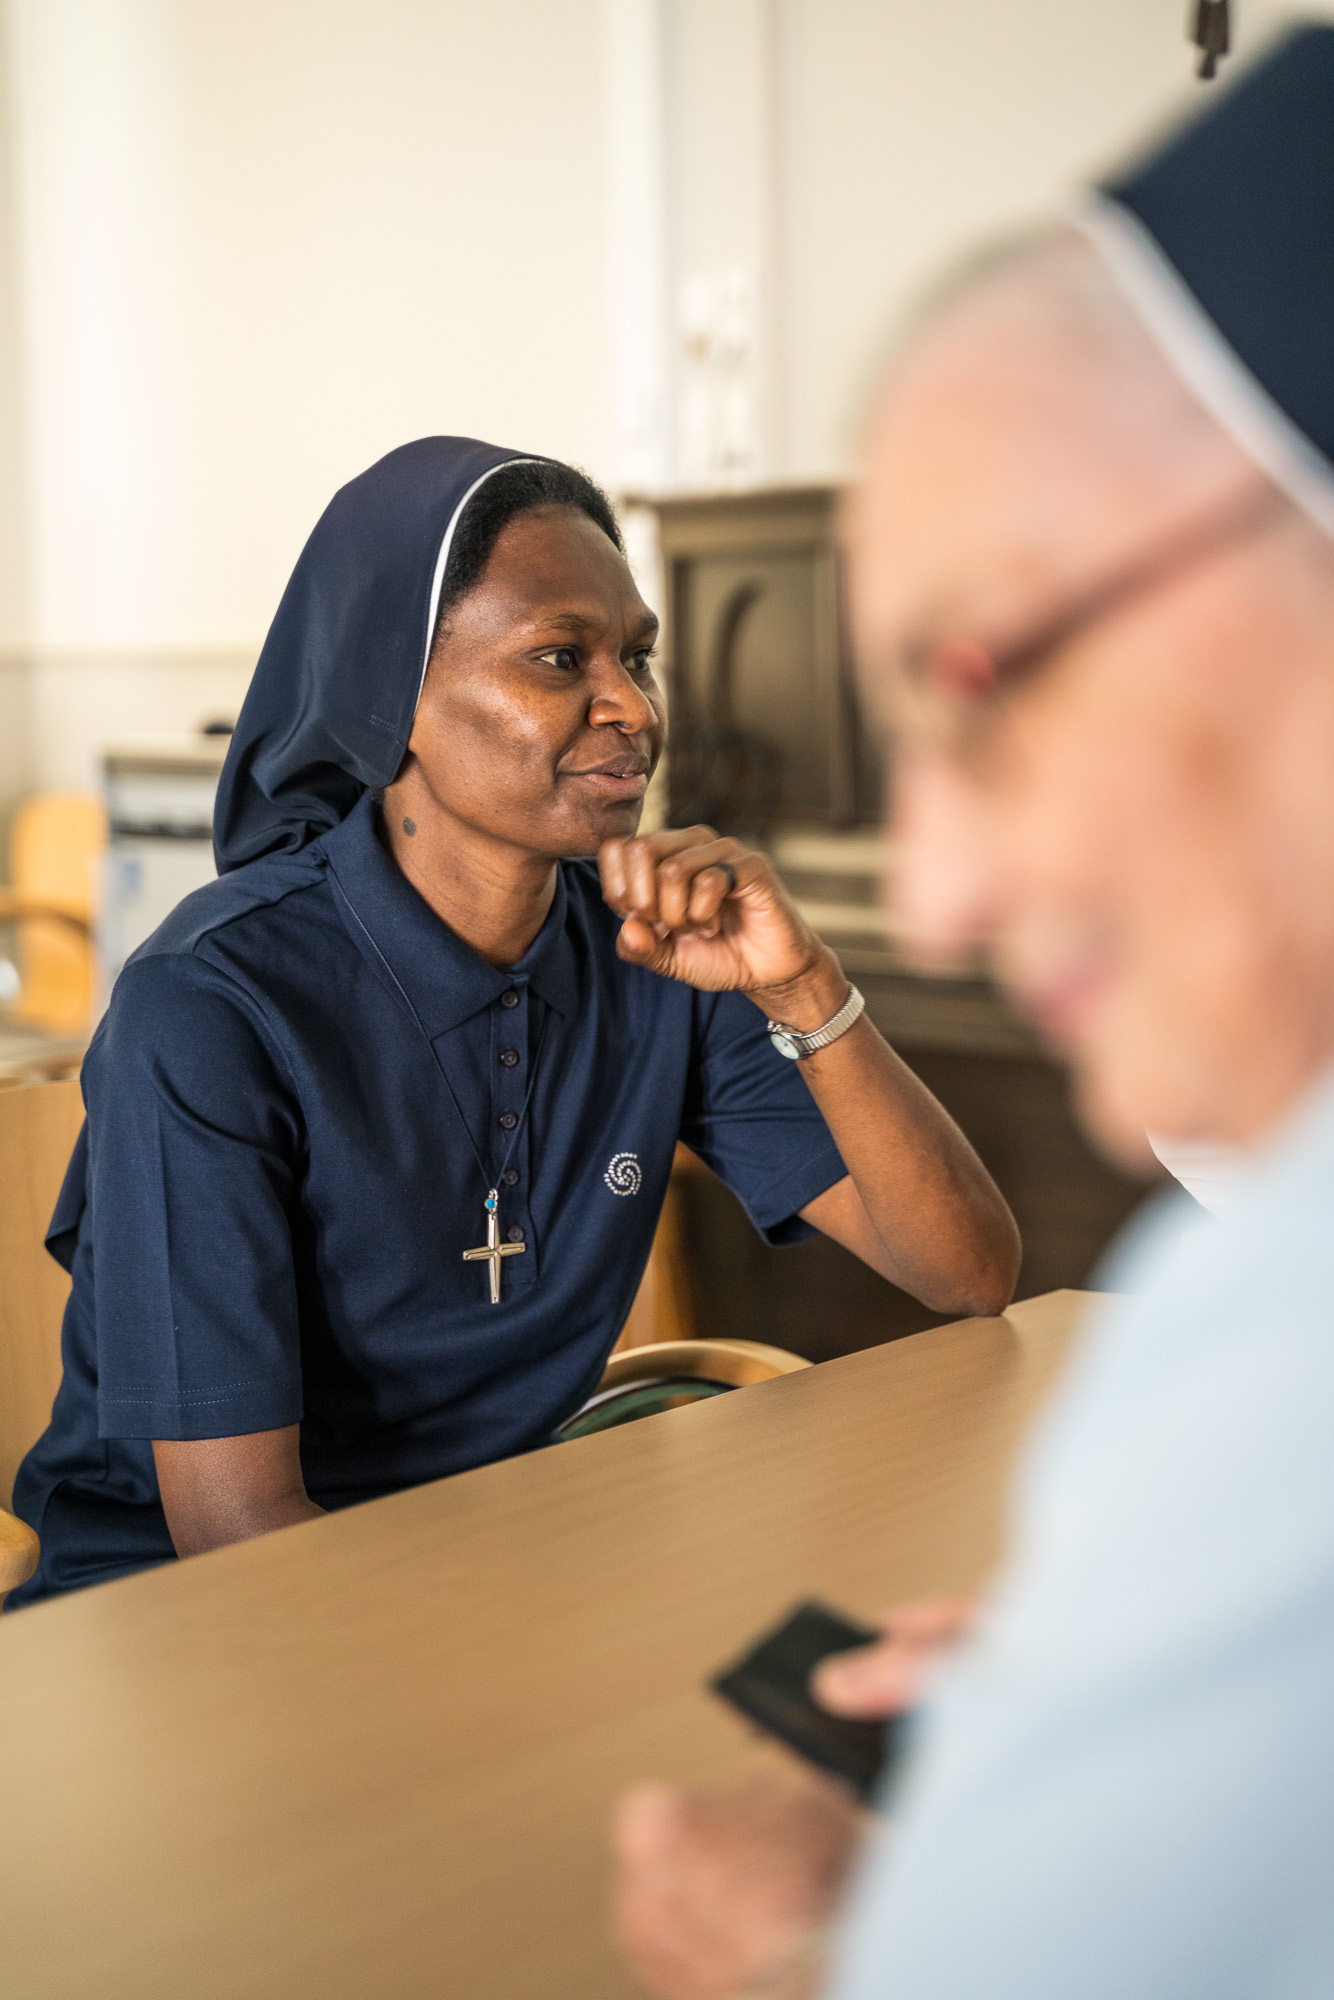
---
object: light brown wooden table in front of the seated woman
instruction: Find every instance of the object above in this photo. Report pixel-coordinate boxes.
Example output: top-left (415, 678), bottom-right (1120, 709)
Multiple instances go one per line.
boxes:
top-left (0, 1292), bottom-right (1080, 2000)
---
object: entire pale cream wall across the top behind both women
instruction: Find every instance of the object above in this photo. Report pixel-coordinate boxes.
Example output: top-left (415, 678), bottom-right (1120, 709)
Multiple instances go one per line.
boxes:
top-left (0, 0), bottom-right (1334, 816)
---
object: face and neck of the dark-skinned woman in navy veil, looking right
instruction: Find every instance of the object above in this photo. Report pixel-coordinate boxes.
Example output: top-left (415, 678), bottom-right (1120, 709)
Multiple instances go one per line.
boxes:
top-left (384, 506), bottom-right (666, 964)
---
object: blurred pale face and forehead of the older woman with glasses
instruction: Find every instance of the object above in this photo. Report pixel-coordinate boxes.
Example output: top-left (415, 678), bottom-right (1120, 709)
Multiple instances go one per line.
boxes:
top-left (848, 230), bottom-right (1334, 1154)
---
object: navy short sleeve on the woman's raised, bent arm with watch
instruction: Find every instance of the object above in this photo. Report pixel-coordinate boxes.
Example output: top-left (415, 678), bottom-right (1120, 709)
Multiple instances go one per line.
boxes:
top-left (680, 994), bottom-right (848, 1244)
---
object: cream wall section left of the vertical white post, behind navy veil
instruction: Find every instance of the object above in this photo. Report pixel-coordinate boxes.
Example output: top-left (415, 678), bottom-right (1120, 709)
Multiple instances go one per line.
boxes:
top-left (0, 0), bottom-right (608, 820)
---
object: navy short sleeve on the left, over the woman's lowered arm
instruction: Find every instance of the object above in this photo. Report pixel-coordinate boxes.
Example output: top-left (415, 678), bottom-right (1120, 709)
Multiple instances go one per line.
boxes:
top-left (82, 954), bottom-right (304, 1438)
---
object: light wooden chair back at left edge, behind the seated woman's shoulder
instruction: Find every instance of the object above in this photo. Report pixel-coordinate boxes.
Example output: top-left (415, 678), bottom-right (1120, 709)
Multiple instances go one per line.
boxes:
top-left (0, 1082), bottom-right (84, 1508)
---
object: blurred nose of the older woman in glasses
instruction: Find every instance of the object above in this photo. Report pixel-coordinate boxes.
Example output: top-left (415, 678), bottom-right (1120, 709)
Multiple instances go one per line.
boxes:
top-left (886, 748), bottom-right (998, 966)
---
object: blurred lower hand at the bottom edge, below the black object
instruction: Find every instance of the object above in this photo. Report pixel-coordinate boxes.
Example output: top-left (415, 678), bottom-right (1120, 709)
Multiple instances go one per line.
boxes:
top-left (614, 1778), bottom-right (864, 2000)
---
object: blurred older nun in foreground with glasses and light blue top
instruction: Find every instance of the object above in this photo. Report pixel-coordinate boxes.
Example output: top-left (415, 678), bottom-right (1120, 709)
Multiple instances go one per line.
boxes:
top-left (618, 28), bottom-right (1334, 2000)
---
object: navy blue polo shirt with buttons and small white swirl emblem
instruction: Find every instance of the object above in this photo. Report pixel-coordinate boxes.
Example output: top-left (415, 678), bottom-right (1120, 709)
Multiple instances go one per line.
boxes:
top-left (10, 796), bottom-right (846, 1604)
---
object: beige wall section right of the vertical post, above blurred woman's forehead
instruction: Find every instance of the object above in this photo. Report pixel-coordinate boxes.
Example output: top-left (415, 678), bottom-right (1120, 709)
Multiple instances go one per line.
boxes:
top-left (778, 0), bottom-right (1334, 476)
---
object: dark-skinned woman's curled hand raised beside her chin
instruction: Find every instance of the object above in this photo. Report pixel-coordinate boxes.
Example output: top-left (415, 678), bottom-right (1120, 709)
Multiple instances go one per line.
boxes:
top-left (598, 826), bottom-right (828, 1008)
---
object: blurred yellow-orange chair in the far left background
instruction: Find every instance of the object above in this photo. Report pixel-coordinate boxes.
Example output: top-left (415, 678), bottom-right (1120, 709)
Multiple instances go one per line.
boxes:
top-left (10, 792), bottom-right (106, 1034)
